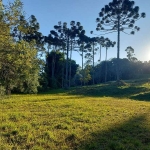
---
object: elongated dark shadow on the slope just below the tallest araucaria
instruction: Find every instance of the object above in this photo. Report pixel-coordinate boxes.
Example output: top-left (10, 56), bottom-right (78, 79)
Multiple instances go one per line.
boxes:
top-left (69, 85), bottom-right (148, 98)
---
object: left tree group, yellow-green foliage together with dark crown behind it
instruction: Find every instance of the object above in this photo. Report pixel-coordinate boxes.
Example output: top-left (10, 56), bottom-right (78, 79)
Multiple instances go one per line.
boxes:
top-left (0, 0), bottom-right (43, 94)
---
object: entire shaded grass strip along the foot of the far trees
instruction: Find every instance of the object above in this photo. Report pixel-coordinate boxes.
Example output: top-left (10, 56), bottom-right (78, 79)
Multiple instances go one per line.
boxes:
top-left (39, 84), bottom-right (150, 101)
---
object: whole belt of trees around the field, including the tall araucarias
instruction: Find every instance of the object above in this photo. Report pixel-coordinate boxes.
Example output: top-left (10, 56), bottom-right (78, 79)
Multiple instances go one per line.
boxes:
top-left (0, 0), bottom-right (150, 95)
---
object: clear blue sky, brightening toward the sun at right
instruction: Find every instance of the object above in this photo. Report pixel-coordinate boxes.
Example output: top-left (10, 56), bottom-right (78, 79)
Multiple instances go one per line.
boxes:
top-left (3, 0), bottom-right (150, 65)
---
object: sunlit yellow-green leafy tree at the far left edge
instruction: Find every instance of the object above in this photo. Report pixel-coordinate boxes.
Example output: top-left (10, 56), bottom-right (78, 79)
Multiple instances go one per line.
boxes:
top-left (0, 0), bottom-right (40, 94)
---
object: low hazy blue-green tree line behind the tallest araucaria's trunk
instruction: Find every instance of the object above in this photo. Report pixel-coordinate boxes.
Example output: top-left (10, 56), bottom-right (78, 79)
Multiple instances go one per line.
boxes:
top-left (75, 58), bottom-right (150, 85)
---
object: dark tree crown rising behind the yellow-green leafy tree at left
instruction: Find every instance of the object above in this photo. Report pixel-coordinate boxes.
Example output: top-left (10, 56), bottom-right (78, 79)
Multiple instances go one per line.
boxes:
top-left (11, 15), bottom-right (45, 52)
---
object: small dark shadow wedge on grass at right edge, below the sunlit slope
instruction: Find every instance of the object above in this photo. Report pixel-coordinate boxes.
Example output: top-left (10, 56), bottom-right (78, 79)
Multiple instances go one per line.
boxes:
top-left (130, 92), bottom-right (150, 102)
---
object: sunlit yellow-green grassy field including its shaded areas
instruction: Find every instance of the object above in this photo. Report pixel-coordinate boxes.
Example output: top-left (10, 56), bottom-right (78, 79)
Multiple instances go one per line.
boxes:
top-left (0, 80), bottom-right (150, 150)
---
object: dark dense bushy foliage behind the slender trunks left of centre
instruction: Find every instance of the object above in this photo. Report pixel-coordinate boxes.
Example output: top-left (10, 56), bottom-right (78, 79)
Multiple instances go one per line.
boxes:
top-left (45, 50), bottom-right (78, 88)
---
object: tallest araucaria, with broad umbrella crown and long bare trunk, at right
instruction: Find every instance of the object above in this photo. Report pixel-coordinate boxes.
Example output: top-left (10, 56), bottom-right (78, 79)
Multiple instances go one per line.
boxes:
top-left (96, 0), bottom-right (146, 81)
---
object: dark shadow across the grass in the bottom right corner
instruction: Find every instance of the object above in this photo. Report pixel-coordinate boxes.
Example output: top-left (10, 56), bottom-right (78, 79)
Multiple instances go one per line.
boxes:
top-left (75, 115), bottom-right (150, 150)
